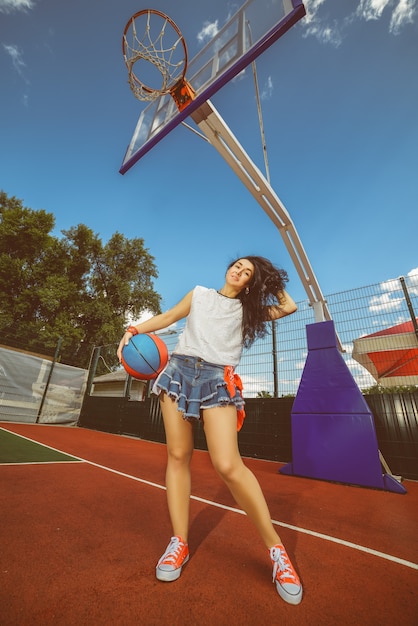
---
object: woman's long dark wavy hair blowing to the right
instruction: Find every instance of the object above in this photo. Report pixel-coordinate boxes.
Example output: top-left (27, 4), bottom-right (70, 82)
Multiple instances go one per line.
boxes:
top-left (228, 256), bottom-right (289, 348)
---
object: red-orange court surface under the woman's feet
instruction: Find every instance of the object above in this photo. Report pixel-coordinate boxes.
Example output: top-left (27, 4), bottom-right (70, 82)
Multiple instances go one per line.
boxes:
top-left (0, 423), bottom-right (418, 626)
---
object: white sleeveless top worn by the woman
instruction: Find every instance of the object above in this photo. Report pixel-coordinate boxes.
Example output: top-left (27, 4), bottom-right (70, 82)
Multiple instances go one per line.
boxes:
top-left (174, 285), bottom-right (243, 367)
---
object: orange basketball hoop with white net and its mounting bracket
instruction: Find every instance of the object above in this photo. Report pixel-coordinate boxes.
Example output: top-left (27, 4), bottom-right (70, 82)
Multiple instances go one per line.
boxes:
top-left (122, 9), bottom-right (195, 111)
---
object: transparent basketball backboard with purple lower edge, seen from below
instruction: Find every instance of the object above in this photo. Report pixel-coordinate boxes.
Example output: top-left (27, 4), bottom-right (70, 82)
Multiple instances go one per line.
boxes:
top-left (119, 0), bottom-right (305, 174)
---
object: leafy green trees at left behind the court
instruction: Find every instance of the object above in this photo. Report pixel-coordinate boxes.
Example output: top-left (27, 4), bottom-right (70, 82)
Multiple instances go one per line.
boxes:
top-left (0, 191), bottom-right (161, 367)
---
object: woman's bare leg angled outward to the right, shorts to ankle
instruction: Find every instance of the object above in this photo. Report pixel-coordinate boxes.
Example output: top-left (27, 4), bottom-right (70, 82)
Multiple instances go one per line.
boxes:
top-left (203, 405), bottom-right (281, 549)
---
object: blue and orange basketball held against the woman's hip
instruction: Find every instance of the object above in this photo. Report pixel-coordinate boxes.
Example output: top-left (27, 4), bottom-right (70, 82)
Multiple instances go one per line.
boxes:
top-left (121, 333), bottom-right (168, 380)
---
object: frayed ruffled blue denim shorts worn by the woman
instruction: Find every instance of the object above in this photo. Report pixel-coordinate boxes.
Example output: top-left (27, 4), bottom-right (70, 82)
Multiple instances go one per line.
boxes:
top-left (152, 354), bottom-right (244, 419)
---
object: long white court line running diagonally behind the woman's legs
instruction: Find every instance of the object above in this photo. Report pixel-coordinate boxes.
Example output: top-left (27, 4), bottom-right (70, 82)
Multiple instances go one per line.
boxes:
top-left (0, 428), bottom-right (418, 570)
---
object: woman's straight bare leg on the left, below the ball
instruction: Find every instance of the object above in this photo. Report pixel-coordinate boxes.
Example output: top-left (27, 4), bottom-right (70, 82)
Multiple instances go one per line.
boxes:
top-left (160, 393), bottom-right (194, 542)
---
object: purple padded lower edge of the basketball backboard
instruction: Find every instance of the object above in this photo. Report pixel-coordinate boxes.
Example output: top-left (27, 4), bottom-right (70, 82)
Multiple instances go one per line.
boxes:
top-left (119, 0), bottom-right (306, 174)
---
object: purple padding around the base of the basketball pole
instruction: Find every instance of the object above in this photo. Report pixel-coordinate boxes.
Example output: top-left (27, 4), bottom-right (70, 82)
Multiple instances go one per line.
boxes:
top-left (279, 321), bottom-right (406, 493)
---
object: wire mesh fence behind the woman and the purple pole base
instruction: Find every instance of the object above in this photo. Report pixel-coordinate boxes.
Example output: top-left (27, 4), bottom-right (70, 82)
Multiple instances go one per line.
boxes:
top-left (89, 273), bottom-right (418, 398)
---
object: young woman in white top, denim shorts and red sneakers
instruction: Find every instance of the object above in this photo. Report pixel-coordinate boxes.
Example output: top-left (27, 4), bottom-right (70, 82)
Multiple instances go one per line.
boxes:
top-left (118, 256), bottom-right (302, 604)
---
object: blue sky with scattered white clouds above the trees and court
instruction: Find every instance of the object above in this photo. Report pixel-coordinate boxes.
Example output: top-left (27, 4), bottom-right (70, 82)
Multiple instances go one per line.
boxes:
top-left (0, 0), bottom-right (418, 309)
